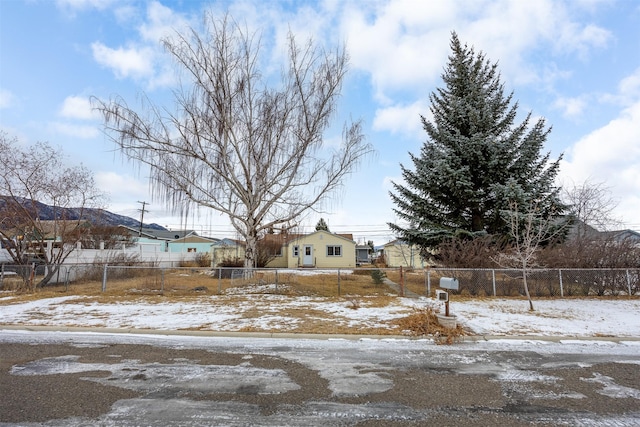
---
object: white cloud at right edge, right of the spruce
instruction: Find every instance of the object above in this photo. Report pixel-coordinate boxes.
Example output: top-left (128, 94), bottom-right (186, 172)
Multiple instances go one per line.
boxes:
top-left (559, 101), bottom-right (640, 223)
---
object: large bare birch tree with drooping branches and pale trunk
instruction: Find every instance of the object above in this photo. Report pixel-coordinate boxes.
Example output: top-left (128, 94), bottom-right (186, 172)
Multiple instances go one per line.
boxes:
top-left (94, 14), bottom-right (371, 267)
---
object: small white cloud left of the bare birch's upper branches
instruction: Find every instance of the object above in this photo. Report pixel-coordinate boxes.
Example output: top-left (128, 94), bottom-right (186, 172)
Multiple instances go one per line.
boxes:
top-left (91, 42), bottom-right (154, 78)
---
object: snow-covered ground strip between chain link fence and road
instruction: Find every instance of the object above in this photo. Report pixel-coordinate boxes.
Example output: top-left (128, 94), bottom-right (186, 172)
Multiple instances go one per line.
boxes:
top-left (0, 294), bottom-right (640, 337)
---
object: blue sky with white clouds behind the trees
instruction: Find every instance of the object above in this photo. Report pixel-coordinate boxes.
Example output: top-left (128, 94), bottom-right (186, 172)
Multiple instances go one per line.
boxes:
top-left (0, 0), bottom-right (640, 244)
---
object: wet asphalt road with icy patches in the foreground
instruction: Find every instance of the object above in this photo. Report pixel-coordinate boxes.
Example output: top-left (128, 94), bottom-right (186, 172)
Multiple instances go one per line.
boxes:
top-left (0, 330), bottom-right (640, 426)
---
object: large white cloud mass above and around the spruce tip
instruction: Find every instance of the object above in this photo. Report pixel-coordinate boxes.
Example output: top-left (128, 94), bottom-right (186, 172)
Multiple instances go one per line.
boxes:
top-left (342, 0), bottom-right (611, 101)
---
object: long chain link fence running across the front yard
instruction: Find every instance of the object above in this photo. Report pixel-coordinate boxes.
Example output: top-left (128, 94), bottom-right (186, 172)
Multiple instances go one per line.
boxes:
top-left (0, 264), bottom-right (640, 297)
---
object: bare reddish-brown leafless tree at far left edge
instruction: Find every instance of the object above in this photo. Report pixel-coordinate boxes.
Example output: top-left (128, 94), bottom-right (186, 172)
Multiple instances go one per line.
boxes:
top-left (0, 133), bottom-right (102, 290)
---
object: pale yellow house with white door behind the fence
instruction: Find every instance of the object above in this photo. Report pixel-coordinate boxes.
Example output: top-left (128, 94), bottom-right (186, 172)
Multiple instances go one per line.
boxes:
top-left (267, 230), bottom-right (356, 268)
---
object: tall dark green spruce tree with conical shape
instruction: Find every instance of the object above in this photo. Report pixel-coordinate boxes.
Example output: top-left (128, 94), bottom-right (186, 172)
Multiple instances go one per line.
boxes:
top-left (389, 33), bottom-right (564, 251)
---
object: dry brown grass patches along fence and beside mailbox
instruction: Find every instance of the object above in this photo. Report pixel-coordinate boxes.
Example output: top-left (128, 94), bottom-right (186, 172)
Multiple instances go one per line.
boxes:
top-left (0, 268), bottom-right (470, 343)
